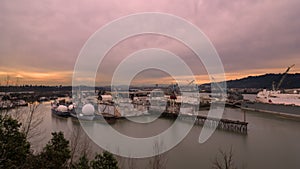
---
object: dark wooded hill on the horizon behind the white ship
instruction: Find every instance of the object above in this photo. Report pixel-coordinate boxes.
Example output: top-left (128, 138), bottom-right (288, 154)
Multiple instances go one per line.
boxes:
top-left (200, 73), bottom-right (300, 89)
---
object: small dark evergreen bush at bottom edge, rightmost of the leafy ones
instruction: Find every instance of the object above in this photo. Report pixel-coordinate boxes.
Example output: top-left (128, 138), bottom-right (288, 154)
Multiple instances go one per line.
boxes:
top-left (91, 151), bottom-right (119, 169)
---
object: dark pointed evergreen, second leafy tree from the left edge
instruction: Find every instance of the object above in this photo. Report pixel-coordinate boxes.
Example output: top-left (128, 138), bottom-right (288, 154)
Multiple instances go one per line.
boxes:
top-left (39, 132), bottom-right (70, 169)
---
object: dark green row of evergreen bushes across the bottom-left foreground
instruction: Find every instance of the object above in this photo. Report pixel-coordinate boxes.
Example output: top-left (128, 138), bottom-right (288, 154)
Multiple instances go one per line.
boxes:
top-left (0, 115), bottom-right (119, 169)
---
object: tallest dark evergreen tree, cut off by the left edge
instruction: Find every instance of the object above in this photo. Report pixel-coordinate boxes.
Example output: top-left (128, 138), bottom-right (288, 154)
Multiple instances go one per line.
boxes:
top-left (0, 115), bottom-right (30, 168)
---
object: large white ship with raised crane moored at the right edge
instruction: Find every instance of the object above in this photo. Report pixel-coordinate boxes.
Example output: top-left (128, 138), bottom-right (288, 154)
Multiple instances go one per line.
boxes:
top-left (241, 65), bottom-right (300, 117)
